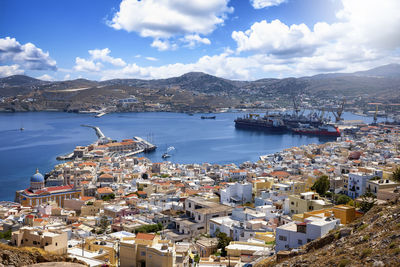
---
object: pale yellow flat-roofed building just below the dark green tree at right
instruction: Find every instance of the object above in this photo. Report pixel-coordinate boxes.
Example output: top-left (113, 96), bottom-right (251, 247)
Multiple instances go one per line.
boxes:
top-left (289, 192), bottom-right (333, 214)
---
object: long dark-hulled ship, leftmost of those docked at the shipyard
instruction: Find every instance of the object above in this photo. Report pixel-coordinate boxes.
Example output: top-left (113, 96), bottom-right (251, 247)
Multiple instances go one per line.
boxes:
top-left (235, 114), bottom-right (288, 132)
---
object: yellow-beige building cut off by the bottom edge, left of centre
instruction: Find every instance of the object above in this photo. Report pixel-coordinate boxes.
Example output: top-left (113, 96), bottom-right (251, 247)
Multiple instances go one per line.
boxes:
top-left (119, 233), bottom-right (176, 267)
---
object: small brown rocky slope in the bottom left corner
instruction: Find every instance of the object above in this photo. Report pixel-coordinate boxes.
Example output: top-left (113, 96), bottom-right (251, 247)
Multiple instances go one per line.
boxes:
top-left (0, 244), bottom-right (85, 266)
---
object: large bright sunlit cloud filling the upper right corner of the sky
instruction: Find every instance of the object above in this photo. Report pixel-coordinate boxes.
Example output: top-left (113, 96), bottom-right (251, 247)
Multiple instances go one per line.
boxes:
top-left (232, 0), bottom-right (400, 73)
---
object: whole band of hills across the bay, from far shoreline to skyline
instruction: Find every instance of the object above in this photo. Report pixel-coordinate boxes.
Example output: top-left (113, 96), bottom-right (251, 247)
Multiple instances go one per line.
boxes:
top-left (0, 64), bottom-right (400, 112)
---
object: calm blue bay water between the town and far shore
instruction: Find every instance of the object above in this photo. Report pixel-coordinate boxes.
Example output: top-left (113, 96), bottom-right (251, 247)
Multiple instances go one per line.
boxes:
top-left (0, 112), bottom-right (382, 200)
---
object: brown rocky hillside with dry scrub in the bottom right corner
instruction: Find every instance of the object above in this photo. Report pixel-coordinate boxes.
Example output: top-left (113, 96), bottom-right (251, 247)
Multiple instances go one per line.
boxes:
top-left (256, 200), bottom-right (400, 267)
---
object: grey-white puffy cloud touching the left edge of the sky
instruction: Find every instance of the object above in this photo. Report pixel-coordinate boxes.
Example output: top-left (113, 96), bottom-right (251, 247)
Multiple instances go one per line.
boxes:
top-left (0, 37), bottom-right (57, 71)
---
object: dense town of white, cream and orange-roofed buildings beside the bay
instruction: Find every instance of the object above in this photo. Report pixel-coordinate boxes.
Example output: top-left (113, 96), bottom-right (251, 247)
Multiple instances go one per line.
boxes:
top-left (0, 120), bottom-right (400, 267)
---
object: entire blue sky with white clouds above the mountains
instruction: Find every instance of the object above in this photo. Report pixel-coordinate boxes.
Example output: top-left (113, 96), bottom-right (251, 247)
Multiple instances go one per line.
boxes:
top-left (0, 0), bottom-right (400, 80)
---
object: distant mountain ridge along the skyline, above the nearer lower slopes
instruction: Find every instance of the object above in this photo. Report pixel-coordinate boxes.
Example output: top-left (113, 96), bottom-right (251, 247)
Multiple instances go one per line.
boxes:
top-left (0, 64), bottom-right (400, 102)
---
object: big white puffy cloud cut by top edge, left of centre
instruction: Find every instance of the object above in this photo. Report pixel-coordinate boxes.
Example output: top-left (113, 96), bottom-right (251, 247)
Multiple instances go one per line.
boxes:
top-left (108, 0), bottom-right (233, 51)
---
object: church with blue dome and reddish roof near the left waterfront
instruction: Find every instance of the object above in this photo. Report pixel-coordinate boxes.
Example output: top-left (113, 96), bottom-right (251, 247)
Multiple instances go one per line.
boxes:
top-left (15, 170), bottom-right (81, 207)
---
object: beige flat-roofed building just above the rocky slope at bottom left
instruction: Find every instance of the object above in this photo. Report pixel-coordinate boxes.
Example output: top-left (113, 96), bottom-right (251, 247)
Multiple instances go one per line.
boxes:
top-left (11, 227), bottom-right (68, 255)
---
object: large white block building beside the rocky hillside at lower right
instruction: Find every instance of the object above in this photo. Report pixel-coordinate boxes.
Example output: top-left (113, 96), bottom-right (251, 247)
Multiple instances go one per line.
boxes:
top-left (275, 217), bottom-right (340, 252)
